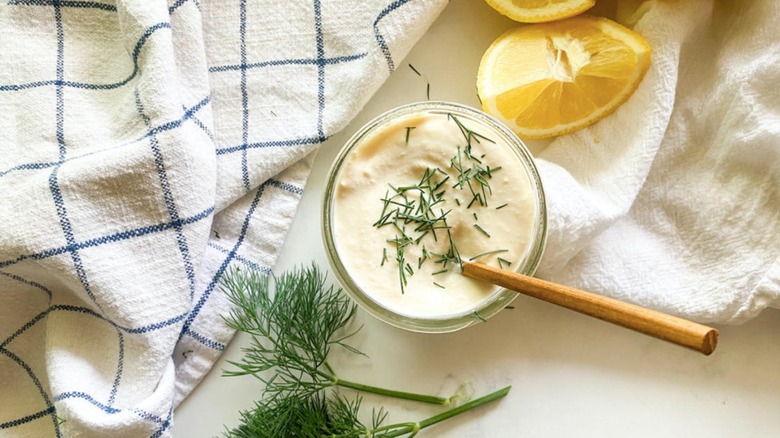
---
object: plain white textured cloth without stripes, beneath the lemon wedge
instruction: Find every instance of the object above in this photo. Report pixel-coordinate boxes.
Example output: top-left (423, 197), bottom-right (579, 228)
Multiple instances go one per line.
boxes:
top-left (539, 0), bottom-right (780, 323)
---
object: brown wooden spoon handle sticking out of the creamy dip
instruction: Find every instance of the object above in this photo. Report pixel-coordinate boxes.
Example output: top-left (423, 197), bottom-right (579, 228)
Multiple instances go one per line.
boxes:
top-left (463, 261), bottom-right (718, 355)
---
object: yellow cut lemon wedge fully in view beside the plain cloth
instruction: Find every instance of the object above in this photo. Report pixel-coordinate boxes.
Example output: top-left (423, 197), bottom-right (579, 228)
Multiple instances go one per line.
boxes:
top-left (477, 15), bottom-right (650, 138)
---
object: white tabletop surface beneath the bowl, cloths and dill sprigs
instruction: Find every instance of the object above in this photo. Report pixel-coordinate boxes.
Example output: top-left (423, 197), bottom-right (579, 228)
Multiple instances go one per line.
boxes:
top-left (173, 0), bottom-right (780, 438)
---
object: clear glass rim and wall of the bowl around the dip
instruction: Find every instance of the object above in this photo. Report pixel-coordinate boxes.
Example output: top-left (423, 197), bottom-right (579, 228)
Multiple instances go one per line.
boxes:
top-left (322, 101), bottom-right (547, 333)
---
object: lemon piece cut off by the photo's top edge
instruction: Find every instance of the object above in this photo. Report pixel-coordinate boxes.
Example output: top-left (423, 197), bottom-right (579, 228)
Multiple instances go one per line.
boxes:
top-left (485, 0), bottom-right (596, 23)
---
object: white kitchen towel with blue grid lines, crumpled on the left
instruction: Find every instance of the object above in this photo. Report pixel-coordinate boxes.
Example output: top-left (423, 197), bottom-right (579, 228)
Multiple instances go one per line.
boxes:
top-left (0, 0), bottom-right (446, 437)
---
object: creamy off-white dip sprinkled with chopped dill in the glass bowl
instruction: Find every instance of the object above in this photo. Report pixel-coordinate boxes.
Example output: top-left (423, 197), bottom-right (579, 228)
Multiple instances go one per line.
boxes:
top-left (332, 108), bottom-right (537, 318)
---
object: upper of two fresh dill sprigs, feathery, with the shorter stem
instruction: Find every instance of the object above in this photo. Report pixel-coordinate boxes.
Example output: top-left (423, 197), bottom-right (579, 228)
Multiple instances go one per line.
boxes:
top-left (222, 265), bottom-right (448, 404)
